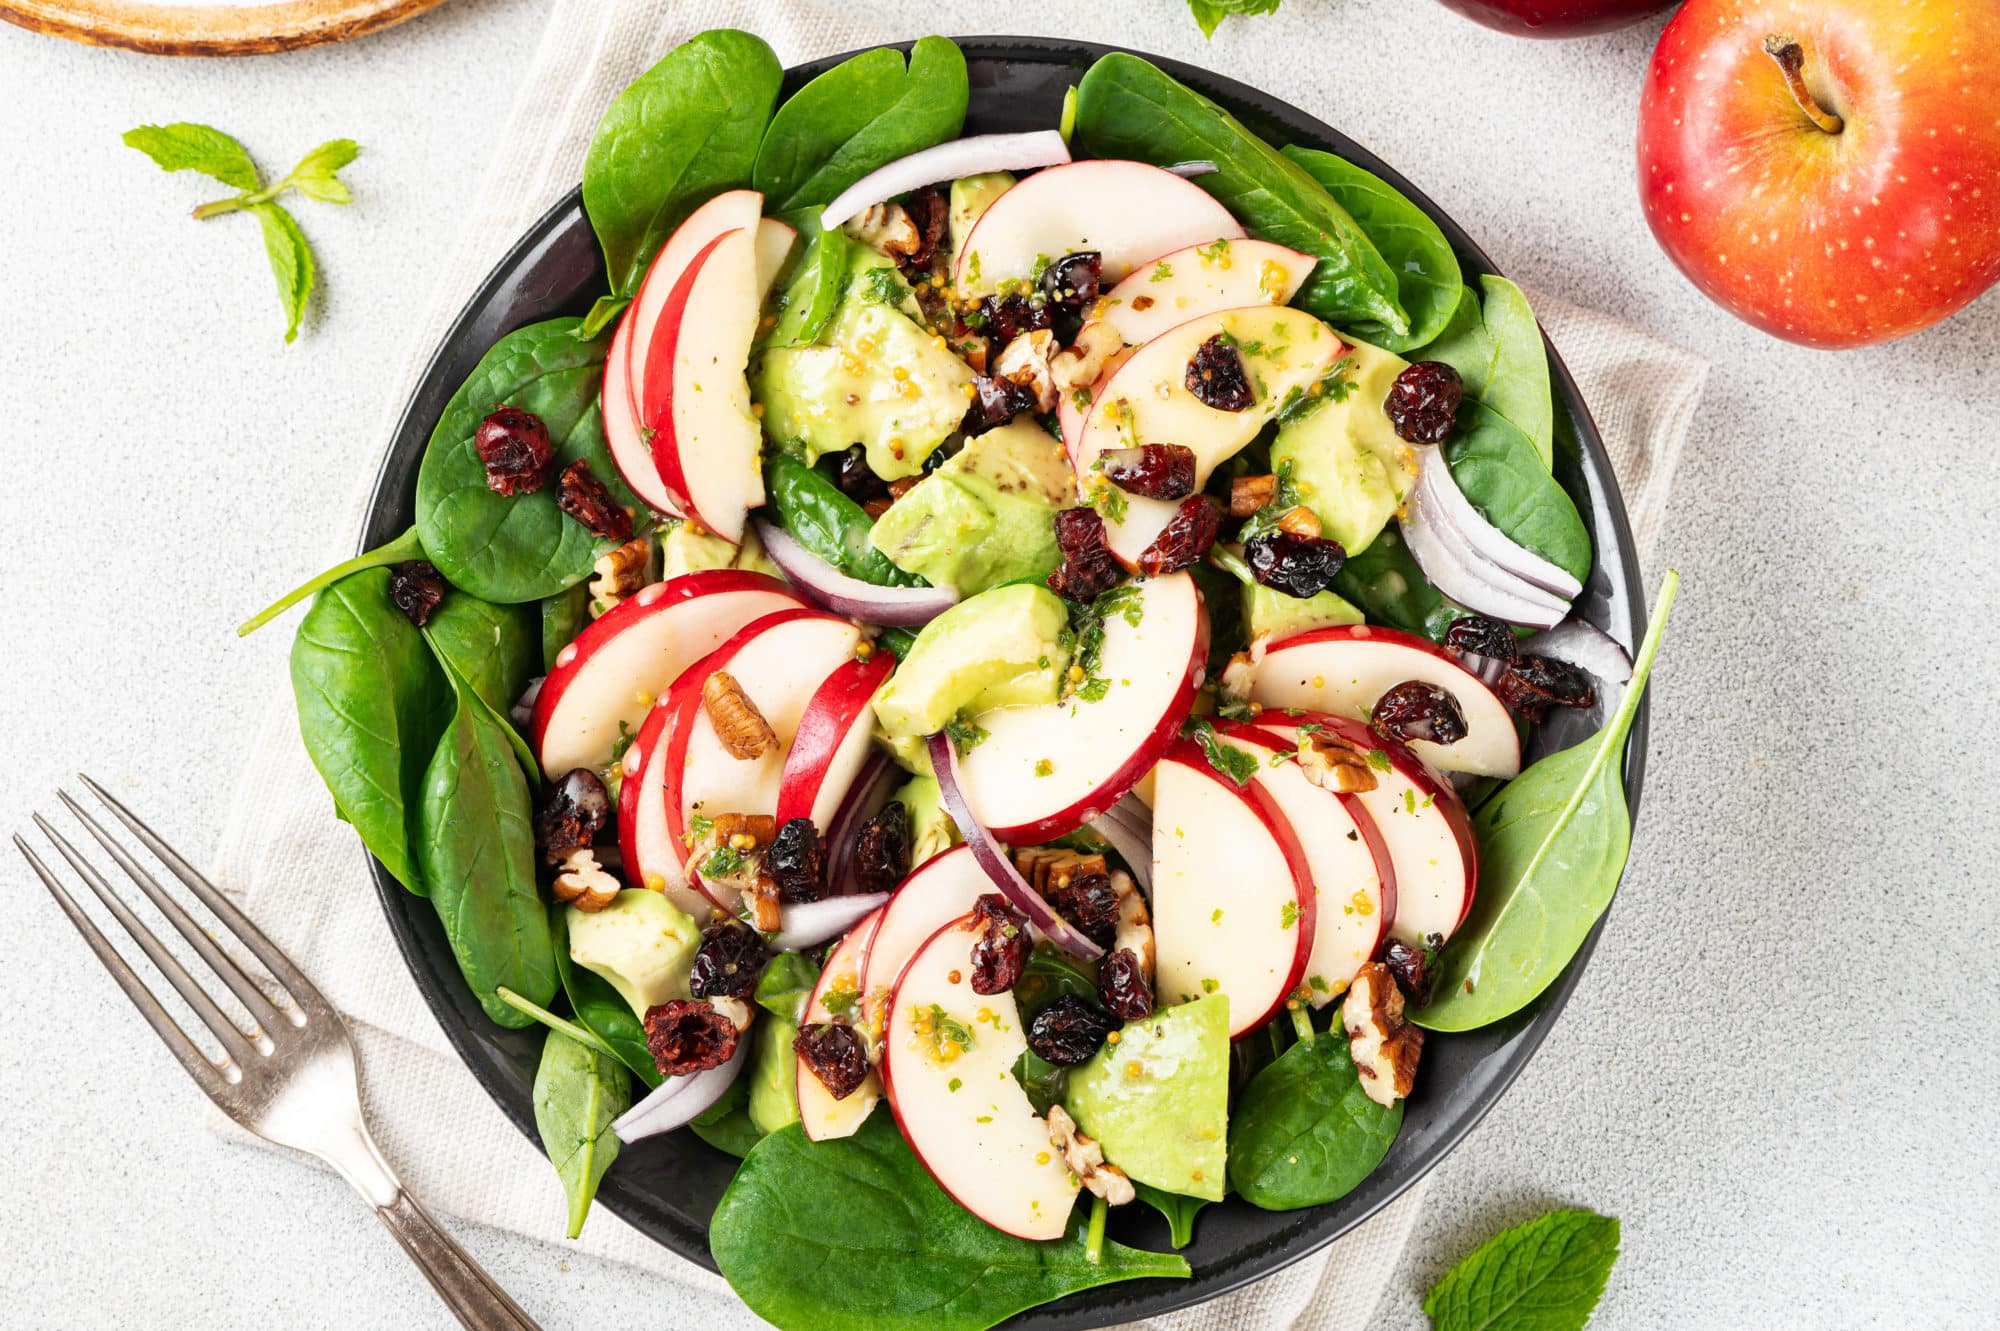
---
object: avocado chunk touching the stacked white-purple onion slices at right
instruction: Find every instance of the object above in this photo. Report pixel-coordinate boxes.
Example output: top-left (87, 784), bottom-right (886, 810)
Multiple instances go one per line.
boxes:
top-left (1270, 338), bottom-right (1416, 556)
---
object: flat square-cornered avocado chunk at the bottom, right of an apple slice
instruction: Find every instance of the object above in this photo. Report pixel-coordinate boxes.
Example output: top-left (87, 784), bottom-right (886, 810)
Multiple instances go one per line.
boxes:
top-left (1064, 993), bottom-right (1230, 1201)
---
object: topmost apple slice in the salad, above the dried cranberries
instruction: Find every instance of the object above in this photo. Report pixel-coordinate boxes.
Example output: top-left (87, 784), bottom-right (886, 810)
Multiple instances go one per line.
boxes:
top-left (954, 160), bottom-right (1244, 296)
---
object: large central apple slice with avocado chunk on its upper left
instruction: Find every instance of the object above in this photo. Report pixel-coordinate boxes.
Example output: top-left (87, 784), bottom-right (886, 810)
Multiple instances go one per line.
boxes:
top-left (958, 574), bottom-right (1208, 845)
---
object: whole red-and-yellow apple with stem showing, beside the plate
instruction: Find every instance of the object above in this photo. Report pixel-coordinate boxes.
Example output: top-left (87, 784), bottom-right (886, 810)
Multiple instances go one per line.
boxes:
top-left (1638, 0), bottom-right (2000, 348)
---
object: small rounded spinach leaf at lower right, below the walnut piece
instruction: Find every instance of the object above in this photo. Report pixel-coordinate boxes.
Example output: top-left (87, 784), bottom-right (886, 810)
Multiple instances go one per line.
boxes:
top-left (1230, 1019), bottom-right (1402, 1211)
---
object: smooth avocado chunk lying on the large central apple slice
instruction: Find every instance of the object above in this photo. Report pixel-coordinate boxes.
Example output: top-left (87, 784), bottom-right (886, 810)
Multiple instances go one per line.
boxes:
top-left (874, 582), bottom-right (1070, 739)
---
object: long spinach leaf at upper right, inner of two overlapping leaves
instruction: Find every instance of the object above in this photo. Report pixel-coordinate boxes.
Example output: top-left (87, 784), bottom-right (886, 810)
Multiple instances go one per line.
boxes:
top-left (1076, 52), bottom-right (1410, 336)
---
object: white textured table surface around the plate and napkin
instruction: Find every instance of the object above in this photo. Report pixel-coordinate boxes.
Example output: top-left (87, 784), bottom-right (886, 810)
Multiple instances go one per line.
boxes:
top-left (0, 0), bottom-right (2000, 1331)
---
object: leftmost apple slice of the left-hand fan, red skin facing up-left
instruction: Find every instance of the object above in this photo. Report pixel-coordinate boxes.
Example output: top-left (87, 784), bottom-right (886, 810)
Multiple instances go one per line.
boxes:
top-left (528, 568), bottom-right (804, 777)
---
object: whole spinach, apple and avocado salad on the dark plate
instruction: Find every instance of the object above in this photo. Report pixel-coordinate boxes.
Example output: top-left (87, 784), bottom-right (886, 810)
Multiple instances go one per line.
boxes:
top-left (252, 30), bottom-right (1672, 1327)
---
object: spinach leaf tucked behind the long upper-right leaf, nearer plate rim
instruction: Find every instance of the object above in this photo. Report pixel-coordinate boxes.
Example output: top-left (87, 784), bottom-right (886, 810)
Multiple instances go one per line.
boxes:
top-left (1284, 144), bottom-right (1464, 352)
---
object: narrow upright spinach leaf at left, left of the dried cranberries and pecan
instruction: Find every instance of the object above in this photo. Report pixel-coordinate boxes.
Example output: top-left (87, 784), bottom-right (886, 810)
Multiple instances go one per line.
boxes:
top-left (416, 689), bottom-right (560, 1027)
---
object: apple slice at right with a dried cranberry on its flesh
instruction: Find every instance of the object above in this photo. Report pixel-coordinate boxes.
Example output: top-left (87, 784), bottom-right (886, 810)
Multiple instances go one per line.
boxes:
top-left (1250, 624), bottom-right (1520, 779)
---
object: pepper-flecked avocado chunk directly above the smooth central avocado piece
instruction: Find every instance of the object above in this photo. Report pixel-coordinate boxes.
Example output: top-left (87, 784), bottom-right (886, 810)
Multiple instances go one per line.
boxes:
top-left (868, 420), bottom-right (1076, 596)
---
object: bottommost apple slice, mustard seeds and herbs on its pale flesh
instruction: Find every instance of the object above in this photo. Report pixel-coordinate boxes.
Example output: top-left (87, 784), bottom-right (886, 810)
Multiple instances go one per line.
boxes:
top-left (882, 915), bottom-right (1080, 1239)
